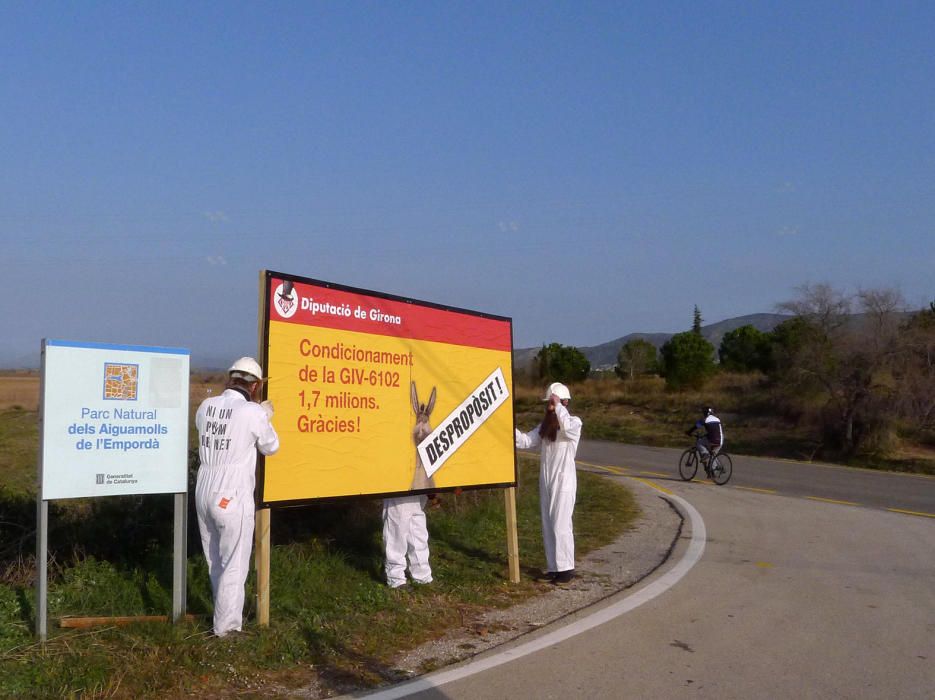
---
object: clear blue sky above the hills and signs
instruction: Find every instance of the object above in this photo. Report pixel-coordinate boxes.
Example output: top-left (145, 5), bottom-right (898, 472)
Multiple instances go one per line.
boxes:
top-left (0, 1), bottom-right (935, 365)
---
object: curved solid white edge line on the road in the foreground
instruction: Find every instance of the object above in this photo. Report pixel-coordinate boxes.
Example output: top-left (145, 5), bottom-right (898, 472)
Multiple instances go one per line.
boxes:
top-left (354, 493), bottom-right (707, 700)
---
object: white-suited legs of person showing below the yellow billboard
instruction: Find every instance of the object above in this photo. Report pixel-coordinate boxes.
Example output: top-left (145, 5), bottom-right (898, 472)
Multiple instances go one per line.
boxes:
top-left (383, 496), bottom-right (432, 588)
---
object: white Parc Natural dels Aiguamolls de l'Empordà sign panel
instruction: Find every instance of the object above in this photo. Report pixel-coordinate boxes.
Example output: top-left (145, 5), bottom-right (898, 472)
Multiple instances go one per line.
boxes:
top-left (39, 340), bottom-right (190, 500)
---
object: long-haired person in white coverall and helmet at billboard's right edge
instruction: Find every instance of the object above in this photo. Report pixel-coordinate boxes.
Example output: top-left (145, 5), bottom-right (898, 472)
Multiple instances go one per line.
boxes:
top-left (516, 382), bottom-right (581, 584)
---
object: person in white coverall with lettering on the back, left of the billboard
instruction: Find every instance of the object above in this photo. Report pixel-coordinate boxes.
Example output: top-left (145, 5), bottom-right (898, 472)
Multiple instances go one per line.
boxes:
top-left (195, 357), bottom-right (279, 637)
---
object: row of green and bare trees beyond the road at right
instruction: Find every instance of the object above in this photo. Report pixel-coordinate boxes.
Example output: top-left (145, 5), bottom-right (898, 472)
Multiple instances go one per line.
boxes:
top-left (537, 284), bottom-right (935, 454)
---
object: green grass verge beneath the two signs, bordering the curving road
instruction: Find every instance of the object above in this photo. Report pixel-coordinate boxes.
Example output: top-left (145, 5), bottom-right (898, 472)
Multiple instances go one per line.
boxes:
top-left (0, 455), bottom-right (638, 698)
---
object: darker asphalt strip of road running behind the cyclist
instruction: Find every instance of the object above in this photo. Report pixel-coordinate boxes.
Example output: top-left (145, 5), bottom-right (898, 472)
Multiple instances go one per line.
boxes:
top-left (578, 440), bottom-right (935, 518)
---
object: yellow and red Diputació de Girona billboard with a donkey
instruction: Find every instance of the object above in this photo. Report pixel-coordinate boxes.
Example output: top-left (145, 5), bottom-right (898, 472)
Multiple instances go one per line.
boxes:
top-left (260, 272), bottom-right (516, 505)
